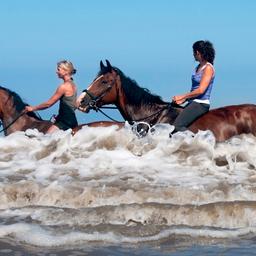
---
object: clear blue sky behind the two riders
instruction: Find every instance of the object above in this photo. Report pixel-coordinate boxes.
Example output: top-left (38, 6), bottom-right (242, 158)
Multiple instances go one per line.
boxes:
top-left (0, 0), bottom-right (256, 123)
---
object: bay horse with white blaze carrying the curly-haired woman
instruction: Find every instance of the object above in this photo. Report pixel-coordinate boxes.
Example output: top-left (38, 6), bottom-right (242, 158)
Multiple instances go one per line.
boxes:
top-left (78, 61), bottom-right (256, 141)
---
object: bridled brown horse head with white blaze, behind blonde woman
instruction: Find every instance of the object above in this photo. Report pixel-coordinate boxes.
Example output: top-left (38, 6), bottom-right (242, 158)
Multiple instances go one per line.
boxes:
top-left (77, 60), bottom-right (120, 113)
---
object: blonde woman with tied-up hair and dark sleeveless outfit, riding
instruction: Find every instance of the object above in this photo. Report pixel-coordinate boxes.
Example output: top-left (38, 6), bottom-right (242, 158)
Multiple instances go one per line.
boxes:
top-left (25, 60), bottom-right (78, 133)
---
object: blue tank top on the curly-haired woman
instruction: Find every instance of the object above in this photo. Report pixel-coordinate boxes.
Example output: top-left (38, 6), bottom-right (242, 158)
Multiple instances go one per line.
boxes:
top-left (190, 62), bottom-right (215, 101)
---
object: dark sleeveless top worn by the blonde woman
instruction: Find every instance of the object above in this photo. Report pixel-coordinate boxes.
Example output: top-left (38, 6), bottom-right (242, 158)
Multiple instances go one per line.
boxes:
top-left (55, 92), bottom-right (78, 130)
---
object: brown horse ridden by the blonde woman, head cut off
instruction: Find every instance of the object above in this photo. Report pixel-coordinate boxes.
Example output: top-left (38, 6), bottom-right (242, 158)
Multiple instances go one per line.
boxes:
top-left (0, 86), bottom-right (122, 135)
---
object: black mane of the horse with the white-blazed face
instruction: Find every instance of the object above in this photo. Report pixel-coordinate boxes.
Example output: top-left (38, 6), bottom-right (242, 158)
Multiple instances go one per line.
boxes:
top-left (98, 67), bottom-right (168, 106)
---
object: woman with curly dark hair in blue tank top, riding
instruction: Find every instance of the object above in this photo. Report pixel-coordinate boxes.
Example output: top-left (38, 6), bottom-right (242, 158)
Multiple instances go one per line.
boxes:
top-left (172, 40), bottom-right (215, 134)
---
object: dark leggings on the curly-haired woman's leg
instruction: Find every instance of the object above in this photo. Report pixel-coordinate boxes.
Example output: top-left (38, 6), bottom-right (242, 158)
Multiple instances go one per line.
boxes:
top-left (171, 101), bottom-right (210, 134)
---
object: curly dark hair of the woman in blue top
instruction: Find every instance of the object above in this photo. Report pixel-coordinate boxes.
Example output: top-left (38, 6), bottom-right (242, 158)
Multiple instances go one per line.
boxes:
top-left (193, 40), bottom-right (215, 64)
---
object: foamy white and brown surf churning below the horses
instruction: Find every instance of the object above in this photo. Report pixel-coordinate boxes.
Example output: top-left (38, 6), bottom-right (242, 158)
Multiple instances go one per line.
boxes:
top-left (0, 125), bottom-right (256, 247)
